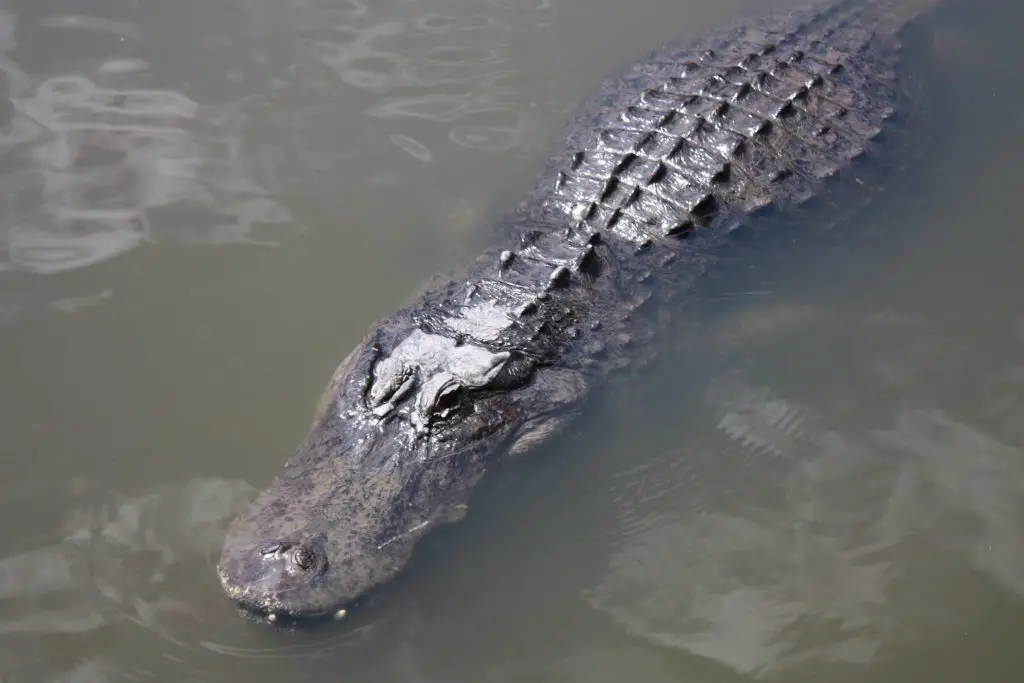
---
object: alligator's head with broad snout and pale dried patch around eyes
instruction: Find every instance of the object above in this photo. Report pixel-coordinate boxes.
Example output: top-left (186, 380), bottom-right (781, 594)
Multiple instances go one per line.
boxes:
top-left (218, 324), bottom-right (585, 621)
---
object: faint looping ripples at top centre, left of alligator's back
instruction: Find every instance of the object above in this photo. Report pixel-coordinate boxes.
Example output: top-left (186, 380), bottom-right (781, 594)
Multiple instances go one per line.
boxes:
top-left (296, 3), bottom-right (547, 141)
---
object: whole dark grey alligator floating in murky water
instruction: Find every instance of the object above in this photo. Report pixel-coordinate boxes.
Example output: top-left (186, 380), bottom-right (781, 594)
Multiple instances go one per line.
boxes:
top-left (217, 0), bottom-right (934, 622)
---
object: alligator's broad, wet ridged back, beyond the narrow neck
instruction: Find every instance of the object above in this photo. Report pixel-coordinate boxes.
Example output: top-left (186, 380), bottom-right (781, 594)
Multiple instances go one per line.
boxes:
top-left (538, 0), bottom-right (931, 244)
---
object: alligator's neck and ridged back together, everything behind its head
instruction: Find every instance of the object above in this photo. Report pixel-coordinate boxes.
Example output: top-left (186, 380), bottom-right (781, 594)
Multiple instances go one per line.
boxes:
top-left (408, 0), bottom-right (932, 368)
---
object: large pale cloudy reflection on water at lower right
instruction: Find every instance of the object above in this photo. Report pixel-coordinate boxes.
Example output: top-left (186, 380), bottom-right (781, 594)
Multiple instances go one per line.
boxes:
top-left (588, 385), bottom-right (1024, 674)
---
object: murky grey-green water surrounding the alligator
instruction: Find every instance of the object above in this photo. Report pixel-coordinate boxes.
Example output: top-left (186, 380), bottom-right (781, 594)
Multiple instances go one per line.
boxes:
top-left (0, 0), bottom-right (1024, 683)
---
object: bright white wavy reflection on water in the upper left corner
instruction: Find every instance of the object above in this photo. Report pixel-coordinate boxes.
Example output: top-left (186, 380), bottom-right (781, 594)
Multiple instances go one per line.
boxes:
top-left (0, 12), bottom-right (291, 273)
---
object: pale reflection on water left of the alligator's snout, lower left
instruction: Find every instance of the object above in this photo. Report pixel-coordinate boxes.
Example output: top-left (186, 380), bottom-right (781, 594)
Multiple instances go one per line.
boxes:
top-left (0, 479), bottom-right (252, 681)
